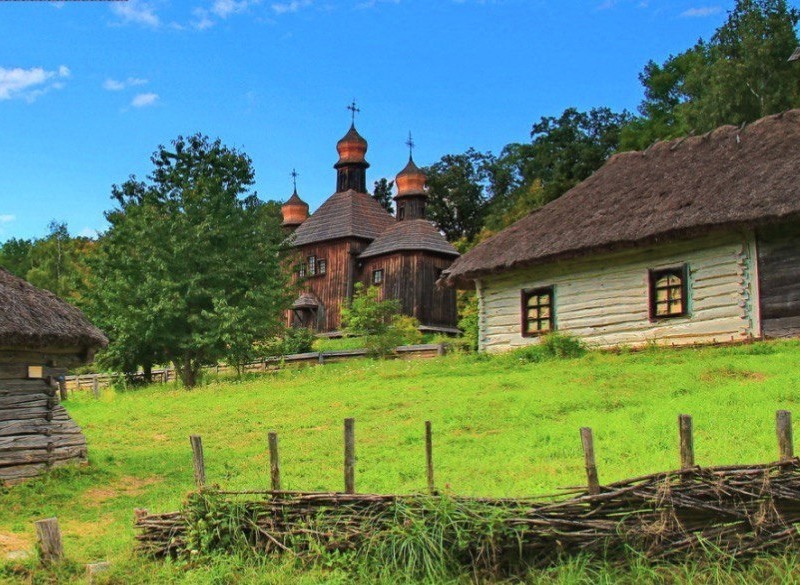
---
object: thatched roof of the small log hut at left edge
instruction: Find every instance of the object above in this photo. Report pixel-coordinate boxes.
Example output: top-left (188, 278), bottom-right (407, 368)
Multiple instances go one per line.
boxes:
top-left (0, 268), bottom-right (108, 350)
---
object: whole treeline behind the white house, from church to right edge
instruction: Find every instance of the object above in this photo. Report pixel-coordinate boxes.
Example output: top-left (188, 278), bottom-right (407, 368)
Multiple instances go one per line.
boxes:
top-left (418, 0), bottom-right (800, 250)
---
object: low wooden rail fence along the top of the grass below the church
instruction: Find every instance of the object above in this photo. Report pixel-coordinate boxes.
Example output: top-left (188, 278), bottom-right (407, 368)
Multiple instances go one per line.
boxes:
top-left (64, 343), bottom-right (446, 393)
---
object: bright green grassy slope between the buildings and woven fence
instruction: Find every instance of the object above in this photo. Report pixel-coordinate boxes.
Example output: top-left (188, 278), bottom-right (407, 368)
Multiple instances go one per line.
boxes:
top-left (0, 342), bottom-right (800, 583)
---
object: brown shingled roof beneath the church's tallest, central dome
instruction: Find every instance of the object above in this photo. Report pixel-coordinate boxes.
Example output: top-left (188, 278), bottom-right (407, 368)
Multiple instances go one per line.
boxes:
top-left (292, 189), bottom-right (395, 246)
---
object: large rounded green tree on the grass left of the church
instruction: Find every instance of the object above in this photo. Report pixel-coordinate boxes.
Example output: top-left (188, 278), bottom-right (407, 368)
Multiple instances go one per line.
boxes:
top-left (90, 134), bottom-right (291, 388)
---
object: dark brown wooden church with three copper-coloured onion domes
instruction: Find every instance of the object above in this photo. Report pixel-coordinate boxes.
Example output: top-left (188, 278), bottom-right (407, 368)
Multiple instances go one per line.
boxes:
top-left (282, 118), bottom-right (459, 334)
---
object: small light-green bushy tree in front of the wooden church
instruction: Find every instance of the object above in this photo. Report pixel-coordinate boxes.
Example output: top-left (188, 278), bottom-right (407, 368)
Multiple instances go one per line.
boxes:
top-left (342, 282), bottom-right (422, 357)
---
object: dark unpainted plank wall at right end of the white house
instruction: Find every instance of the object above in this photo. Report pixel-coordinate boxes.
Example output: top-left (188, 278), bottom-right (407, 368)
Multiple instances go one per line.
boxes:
top-left (758, 226), bottom-right (800, 337)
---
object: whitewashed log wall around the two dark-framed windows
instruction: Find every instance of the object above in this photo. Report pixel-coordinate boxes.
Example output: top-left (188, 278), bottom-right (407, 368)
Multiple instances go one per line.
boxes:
top-left (477, 233), bottom-right (760, 352)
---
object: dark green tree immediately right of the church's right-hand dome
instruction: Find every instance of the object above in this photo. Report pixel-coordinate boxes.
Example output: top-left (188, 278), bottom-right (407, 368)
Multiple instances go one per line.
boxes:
top-left (425, 148), bottom-right (494, 242)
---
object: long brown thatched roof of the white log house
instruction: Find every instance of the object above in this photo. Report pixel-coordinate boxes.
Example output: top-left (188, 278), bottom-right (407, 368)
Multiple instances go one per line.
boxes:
top-left (445, 110), bottom-right (800, 286)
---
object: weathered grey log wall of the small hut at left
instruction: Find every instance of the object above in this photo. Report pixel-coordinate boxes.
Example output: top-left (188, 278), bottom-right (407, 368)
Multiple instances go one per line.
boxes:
top-left (0, 352), bottom-right (86, 485)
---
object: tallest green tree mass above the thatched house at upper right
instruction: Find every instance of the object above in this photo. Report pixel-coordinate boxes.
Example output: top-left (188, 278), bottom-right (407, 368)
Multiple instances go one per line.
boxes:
top-left (622, 0), bottom-right (800, 149)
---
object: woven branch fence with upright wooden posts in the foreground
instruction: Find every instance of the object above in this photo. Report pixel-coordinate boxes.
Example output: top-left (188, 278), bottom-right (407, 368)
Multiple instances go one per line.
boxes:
top-left (135, 411), bottom-right (800, 573)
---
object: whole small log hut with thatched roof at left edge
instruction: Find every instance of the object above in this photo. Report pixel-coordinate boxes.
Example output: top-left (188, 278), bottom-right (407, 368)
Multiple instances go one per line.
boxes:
top-left (0, 268), bottom-right (108, 484)
